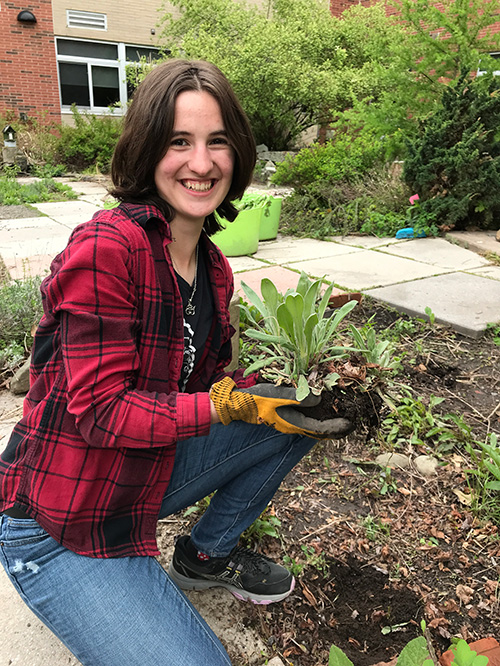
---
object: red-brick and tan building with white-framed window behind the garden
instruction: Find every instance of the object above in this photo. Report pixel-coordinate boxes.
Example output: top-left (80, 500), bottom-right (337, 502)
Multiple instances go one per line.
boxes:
top-left (0, 0), bottom-right (500, 122)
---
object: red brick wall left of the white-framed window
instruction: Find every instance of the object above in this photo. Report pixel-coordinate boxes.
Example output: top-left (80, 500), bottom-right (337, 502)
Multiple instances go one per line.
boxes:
top-left (0, 0), bottom-right (61, 122)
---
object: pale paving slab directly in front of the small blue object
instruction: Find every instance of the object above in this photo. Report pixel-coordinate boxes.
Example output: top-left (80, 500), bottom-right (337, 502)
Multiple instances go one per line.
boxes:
top-left (377, 238), bottom-right (488, 271)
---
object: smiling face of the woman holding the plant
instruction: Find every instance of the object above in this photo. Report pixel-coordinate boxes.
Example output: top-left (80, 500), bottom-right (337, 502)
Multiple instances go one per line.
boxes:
top-left (155, 91), bottom-right (234, 224)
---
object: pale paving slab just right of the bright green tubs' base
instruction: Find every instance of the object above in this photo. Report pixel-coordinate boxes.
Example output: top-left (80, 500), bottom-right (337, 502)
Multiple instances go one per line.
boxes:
top-left (253, 238), bottom-right (362, 262)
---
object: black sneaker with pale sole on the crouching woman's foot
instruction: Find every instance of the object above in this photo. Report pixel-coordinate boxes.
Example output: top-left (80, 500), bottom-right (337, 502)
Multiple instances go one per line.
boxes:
top-left (168, 536), bottom-right (295, 604)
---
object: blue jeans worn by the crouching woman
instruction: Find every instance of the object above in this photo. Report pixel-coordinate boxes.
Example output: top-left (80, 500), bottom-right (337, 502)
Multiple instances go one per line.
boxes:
top-left (0, 421), bottom-right (315, 666)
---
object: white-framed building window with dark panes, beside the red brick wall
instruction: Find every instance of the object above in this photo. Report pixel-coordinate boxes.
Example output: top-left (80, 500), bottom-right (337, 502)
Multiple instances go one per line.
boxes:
top-left (56, 37), bottom-right (159, 114)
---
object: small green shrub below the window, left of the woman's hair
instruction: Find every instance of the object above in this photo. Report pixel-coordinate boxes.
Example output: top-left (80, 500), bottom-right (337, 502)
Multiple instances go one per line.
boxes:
top-left (53, 107), bottom-right (122, 173)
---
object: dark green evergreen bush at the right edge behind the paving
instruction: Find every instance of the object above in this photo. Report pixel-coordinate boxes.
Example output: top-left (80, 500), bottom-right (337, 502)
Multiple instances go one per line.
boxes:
top-left (403, 72), bottom-right (500, 229)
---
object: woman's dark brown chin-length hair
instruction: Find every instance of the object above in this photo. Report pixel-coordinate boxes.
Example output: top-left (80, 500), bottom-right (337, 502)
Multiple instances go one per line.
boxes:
top-left (110, 59), bottom-right (256, 235)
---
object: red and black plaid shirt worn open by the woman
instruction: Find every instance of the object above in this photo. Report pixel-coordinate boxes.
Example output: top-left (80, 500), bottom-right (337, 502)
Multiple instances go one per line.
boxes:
top-left (0, 204), bottom-right (255, 557)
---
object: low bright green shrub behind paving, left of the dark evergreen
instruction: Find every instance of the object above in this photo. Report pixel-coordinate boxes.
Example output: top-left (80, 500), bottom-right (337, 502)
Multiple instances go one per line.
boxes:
top-left (271, 132), bottom-right (382, 190)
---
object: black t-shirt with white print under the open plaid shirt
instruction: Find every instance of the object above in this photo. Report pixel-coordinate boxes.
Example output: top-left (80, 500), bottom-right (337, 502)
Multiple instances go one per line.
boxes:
top-left (175, 244), bottom-right (214, 391)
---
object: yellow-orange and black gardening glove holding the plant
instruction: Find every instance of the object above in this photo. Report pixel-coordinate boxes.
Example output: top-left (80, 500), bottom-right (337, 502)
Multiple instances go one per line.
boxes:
top-left (210, 377), bottom-right (354, 439)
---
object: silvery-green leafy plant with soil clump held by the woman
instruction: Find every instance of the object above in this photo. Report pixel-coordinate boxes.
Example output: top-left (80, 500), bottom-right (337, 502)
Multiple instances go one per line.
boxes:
top-left (242, 273), bottom-right (399, 425)
